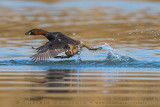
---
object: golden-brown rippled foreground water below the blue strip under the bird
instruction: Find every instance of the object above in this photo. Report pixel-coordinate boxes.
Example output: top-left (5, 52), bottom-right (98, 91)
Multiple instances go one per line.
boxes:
top-left (0, 68), bottom-right (160, 107)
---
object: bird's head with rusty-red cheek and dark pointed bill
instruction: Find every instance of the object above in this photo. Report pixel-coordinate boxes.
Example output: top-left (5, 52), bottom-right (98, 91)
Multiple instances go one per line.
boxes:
top-left (25, 29), bottom-right (46, 35)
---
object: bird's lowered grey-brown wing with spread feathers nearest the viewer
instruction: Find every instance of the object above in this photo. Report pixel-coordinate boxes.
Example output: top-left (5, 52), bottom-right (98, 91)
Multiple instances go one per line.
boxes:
top-left (31, 40), bottom-right (69, 60)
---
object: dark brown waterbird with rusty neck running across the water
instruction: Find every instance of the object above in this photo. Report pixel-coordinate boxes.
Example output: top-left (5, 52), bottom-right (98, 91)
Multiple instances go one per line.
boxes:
top-left (25, 29), bottom-right (101, 61)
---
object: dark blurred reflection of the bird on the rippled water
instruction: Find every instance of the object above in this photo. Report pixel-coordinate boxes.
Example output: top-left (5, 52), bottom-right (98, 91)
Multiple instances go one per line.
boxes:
top-left (30, 69), bottom-right (79, 100)
